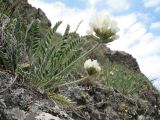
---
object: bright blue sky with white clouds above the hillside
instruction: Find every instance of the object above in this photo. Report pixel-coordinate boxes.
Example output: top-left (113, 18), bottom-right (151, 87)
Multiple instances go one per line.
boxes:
top-left (28, 0), bottom-right (160, 88)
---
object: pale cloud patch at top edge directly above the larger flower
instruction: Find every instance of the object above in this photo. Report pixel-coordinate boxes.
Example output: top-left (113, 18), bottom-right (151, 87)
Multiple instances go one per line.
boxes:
top-left (106, 0), bottom-right (131, 12)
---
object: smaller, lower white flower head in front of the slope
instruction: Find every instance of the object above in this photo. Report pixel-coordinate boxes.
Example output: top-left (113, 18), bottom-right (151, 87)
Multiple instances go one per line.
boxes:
top-left (84, 59), bottom-right (101, 75)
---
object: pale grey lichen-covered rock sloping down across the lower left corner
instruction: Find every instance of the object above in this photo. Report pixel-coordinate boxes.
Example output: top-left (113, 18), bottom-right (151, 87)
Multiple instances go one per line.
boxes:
top-left (0, 71), bottom-right (72, 120)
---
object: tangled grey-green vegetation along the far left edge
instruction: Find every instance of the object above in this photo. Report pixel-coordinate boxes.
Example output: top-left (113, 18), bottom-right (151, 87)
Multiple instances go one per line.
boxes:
top-left (0, 13), bottom-right (25, 72)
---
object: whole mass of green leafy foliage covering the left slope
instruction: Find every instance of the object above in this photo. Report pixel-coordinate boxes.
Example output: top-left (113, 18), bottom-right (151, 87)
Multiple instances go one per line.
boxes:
top-left (1, 6), bottom-right (101, 91)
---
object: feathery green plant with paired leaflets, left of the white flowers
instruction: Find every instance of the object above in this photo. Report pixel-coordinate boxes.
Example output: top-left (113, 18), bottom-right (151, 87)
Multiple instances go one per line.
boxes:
top-left (21, 13), bottom-right (119, 90)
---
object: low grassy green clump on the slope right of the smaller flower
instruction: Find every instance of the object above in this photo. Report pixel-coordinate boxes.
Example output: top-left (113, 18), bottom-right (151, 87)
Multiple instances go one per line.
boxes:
top-left (103, 60), bottom-right (152, 94)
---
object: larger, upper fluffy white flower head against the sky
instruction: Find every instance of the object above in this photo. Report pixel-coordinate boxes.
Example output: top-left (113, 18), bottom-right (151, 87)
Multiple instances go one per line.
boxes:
top-left (88, 14), bottom-right (119, 42)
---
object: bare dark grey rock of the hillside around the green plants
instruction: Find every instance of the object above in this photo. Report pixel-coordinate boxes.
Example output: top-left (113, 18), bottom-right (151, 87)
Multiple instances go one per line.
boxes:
top-left (0, 0), bottom-right (160, 120)
